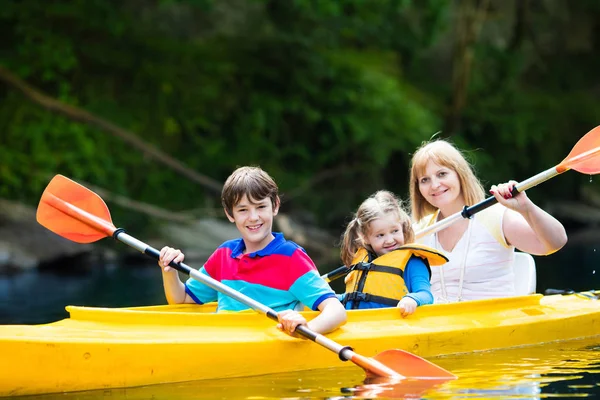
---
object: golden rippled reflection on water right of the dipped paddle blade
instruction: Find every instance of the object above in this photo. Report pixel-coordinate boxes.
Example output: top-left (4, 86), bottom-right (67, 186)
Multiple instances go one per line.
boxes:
top-left (428, 336), bottom-right (600, 399)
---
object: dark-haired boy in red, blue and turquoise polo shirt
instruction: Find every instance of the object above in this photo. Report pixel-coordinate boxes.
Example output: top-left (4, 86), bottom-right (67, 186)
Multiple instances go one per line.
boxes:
top-left (158, 167), bottom-right (346, 335)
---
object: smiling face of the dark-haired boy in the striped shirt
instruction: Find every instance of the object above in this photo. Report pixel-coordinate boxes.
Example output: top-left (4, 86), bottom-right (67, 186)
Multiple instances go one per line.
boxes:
top-left (225, 195), bottom-right (279, 253)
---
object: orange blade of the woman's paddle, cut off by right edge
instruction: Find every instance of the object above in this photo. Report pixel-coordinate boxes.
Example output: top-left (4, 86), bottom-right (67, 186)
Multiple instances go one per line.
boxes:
top-left (556, 126), bottom-right (600, 175)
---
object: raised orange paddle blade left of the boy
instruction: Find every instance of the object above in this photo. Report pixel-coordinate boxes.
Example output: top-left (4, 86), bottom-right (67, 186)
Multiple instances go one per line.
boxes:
top-left (36, 175), bottom-right (117, 243)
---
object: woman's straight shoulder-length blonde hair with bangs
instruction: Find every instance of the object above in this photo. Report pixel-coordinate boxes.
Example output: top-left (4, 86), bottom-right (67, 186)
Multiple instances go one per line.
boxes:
top-left (410, 139), bottom-right (485, 221)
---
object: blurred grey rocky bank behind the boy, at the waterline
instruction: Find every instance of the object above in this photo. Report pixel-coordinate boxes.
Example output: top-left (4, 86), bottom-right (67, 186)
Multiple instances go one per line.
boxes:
top-left (0, 199), bottom-right (338, 271)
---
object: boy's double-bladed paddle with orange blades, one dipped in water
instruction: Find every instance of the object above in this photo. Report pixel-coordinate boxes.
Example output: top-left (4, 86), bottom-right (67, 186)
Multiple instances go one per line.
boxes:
top-left (37, 175), bottom-right (455, 379)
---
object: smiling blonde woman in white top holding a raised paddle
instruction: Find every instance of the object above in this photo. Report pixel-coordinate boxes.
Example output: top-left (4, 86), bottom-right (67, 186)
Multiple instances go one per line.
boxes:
top-left (410, 140), bottom-right (567, 303)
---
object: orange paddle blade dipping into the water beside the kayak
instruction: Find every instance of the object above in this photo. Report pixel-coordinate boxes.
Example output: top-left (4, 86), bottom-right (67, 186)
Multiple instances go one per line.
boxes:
top-left (373, 349), bottom-right (456, 379)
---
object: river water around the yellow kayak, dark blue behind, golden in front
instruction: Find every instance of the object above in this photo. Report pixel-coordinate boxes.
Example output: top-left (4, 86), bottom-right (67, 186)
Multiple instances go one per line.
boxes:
top-left (0, 241), bottom-right (600, 400)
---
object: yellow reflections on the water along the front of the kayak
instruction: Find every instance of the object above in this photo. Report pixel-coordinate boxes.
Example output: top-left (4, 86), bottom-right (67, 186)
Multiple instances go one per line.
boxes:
top-left (15, 336), bottom-right (600, 400)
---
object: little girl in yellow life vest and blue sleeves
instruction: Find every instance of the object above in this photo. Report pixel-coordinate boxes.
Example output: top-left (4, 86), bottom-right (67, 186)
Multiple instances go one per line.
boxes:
top-left (341, 190), bottom-right (447, 317)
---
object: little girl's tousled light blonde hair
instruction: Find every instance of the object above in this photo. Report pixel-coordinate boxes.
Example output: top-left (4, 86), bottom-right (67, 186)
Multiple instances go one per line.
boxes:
top-left (340, 190), bottom-right (415, 266)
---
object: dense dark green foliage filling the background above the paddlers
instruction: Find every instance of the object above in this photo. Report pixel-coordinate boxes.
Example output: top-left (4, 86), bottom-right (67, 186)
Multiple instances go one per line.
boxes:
top-left (0, 0), bottom-right (600, 231)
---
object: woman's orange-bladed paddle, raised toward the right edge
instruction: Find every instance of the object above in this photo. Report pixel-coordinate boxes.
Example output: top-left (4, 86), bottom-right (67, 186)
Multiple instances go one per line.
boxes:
top-left (321, 126), bottom-right (600, 282)
